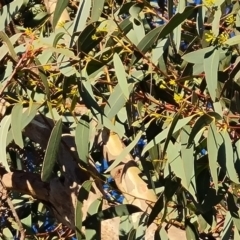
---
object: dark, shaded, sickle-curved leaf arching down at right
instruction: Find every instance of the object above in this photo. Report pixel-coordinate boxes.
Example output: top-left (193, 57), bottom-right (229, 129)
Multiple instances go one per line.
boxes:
top-left (188, 112), bottom-right (222, 147)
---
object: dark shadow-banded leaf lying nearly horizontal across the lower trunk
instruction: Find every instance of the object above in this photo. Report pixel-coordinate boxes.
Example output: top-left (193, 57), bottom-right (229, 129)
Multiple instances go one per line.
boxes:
top-left (83, 204), bottom-right (142, 227)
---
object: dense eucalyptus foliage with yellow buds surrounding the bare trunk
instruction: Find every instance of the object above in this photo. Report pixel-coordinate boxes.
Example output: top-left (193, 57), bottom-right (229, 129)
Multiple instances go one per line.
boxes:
top-left (0, 0), bottom-right (240, 240)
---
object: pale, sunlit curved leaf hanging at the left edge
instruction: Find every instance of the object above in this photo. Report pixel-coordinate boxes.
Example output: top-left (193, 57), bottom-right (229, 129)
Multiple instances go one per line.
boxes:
top-left (0, 115), bottom-right (11, 171)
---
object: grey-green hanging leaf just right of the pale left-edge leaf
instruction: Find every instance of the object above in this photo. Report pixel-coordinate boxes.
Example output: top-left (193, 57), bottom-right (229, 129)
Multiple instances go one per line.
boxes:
top-left (11, 103), bottom-right (24, 148)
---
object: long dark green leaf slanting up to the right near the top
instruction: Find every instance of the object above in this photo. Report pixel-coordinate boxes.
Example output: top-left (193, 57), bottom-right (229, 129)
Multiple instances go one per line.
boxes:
top-left (131, 6), bottom-right (195, 65)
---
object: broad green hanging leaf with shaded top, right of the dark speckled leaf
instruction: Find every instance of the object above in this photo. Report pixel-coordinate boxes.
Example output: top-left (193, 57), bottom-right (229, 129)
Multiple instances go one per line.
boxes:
top-left (75, 115), bottom-right (90, 164)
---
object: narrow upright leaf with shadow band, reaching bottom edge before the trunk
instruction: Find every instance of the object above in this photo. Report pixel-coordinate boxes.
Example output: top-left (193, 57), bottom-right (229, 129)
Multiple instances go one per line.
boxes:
top-left (75, 180), bottom-right (92, 240)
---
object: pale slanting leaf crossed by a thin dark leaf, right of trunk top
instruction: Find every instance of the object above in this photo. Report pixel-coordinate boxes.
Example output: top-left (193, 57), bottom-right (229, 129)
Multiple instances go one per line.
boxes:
top-left (141, 116), bottom-right (193, 156)
